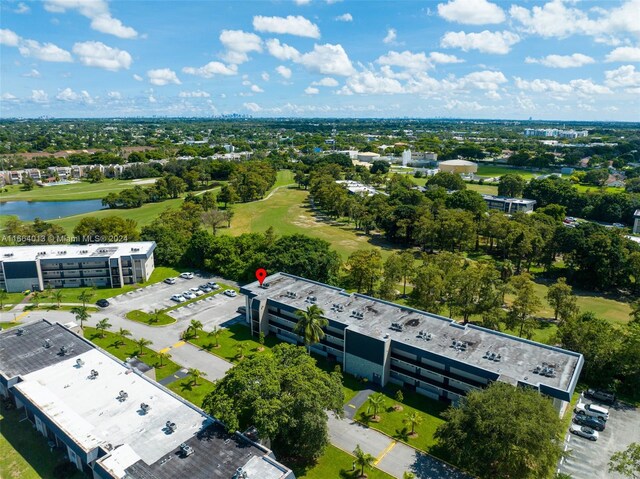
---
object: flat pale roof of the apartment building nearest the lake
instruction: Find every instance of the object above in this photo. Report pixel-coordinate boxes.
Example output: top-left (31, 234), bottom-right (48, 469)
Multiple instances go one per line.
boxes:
top-left (0, 241), bottom-right (156, 262)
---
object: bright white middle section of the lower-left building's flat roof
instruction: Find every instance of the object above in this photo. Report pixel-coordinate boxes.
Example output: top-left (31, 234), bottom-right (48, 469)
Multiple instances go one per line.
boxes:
top-left (14, 349), bottom-right (211, 466)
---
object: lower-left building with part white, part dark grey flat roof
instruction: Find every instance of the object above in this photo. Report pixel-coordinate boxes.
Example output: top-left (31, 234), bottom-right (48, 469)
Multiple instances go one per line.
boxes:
top-left (0, 320), bottom-right (294, 479)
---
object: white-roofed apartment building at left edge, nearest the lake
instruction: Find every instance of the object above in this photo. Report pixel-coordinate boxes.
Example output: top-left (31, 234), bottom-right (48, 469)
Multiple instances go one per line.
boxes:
top-left (0, 241), bottom-right (156, 293)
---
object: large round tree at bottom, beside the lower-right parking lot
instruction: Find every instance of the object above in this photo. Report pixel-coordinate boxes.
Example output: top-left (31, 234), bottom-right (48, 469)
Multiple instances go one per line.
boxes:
top-left (434, 382), bottom-right (565, 479)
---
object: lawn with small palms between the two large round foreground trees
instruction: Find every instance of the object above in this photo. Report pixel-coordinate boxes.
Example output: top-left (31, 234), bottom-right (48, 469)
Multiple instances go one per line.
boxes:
top-left (355, 385), bottom-right (448, 452)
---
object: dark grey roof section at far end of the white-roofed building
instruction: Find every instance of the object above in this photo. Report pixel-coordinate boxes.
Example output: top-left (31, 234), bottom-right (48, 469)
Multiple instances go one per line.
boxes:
top-left (0, 321), bottom-right (93, 379)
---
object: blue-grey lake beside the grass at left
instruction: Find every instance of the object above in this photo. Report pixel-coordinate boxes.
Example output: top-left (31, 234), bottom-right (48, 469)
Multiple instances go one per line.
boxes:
top-left (0, 200), bottom-right (103, 221)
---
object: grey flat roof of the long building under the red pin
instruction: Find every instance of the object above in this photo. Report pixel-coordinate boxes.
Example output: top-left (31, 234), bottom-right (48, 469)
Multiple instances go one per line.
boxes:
top-left (241, 273), bottom-right (582, 391)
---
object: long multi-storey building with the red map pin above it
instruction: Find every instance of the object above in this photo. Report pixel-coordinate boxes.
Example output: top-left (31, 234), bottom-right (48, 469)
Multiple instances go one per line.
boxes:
top-left (240, 273), bottom-right (584, 411)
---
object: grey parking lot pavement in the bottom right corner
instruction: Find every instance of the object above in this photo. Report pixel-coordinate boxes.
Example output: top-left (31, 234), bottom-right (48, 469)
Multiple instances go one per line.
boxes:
top-left (559, 397), bottom-right (640, 479)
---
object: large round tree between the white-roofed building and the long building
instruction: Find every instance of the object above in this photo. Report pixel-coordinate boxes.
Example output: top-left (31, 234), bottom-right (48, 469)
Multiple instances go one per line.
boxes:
top-left (202, 344), bottom-right (344, 463)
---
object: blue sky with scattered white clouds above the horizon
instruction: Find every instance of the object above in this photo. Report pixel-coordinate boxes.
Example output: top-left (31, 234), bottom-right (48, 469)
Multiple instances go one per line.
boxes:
top-left (0, 0), bottom-right (640, 121)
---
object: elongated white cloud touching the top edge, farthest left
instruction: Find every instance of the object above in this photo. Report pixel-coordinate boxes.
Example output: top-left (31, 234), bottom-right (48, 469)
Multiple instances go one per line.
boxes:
top-left (44, 0), bottom-right (138, 38)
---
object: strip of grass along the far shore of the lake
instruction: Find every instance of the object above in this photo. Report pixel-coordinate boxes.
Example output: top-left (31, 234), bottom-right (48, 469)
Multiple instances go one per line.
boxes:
top-left (0, 180), bottom-right (154, 202)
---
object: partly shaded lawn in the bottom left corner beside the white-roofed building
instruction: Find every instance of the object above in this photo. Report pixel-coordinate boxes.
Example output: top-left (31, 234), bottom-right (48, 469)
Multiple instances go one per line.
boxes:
top-left (0, 408), bottom-right (85, 479)
